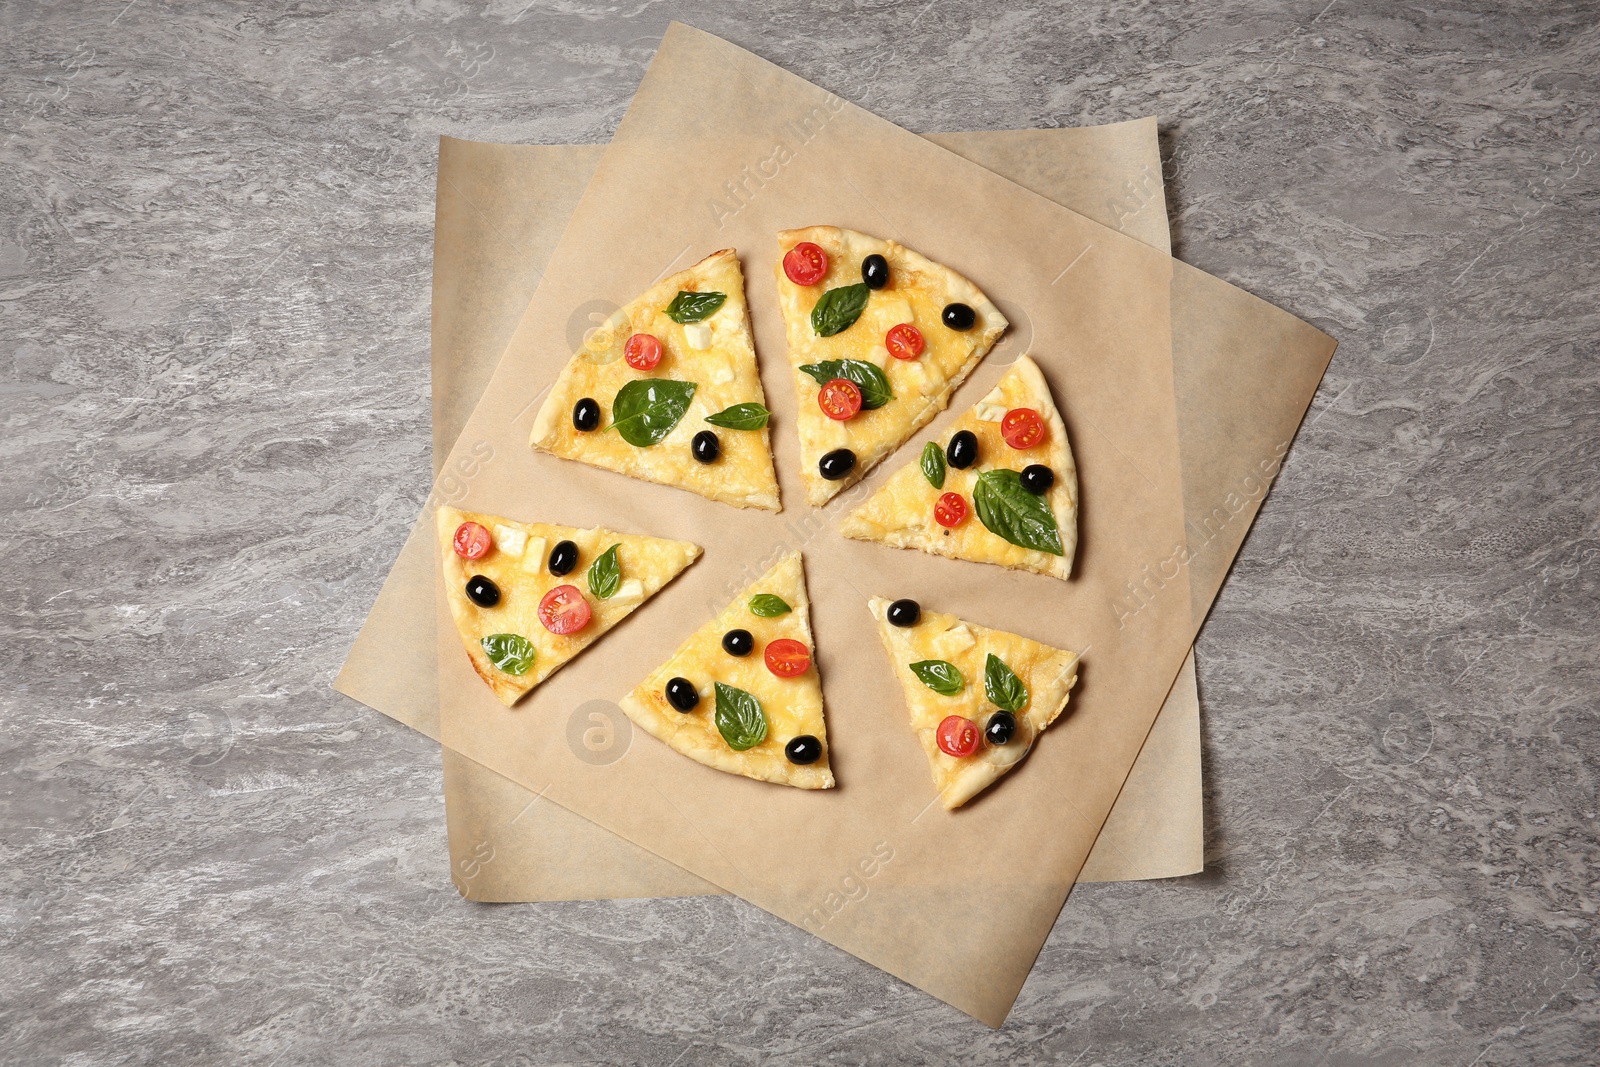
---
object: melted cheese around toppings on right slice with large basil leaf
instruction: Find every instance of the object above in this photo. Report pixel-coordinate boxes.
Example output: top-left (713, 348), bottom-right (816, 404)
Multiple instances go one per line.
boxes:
top-left (838, 355), bottom-right (1078, 579)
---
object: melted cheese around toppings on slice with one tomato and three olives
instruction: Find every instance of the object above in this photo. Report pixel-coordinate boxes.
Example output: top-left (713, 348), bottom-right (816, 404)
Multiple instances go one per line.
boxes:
top-left (621, 552), bottom-right (834, 789)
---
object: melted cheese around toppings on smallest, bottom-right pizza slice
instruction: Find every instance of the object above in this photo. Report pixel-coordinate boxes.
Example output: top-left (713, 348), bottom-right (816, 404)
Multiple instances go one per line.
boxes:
top-left (870, 597), bottom-right (1078, 811)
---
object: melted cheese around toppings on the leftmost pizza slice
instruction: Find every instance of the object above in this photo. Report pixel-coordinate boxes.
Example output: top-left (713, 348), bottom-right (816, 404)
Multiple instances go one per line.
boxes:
top-left (435, 506), bottom-right (701, 707)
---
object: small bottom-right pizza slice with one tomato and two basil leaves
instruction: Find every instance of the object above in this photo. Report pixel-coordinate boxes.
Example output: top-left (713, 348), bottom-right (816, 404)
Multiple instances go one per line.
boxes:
top-left (872, 597), bottom-right (1078, 811)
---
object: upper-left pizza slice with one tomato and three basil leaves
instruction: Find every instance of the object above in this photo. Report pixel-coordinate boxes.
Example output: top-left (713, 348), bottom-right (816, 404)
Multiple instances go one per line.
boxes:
top-left (531, 248), bottom-right (779, 512)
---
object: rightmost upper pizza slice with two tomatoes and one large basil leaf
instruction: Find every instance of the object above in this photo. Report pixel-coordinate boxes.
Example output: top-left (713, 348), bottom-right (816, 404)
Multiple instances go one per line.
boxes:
top-left (838, 355), bottom-right (1078, 577)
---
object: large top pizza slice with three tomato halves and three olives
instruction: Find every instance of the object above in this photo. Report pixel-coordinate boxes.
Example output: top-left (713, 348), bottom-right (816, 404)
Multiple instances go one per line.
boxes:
top-left (778, 226), bottom-right (1006, 506)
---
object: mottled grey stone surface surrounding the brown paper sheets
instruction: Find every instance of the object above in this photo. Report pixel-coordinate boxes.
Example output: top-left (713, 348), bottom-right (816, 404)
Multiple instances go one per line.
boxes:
top-left (0, 0), bottom-right (1600, 1067)
